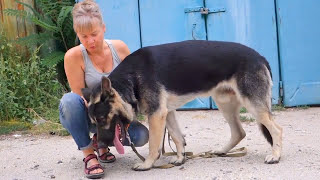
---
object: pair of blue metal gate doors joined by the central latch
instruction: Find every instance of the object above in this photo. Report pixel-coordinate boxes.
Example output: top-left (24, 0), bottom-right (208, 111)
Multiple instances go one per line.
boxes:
top-left (139, 0), bottom-right (279, 109)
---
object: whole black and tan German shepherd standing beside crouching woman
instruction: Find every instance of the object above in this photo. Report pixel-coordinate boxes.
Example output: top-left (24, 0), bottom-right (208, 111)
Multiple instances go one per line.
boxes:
top-left (82, 40), bottom-right (282, 170)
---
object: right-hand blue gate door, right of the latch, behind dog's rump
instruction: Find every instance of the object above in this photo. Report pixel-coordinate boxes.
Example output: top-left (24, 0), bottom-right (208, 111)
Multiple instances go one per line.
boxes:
top-left (205, 0), bottom-right (280, 107)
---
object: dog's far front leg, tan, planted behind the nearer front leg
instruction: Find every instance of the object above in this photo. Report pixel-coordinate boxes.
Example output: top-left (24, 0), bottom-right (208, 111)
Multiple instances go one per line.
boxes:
top-left (166, 110), bottom-right (186, 166)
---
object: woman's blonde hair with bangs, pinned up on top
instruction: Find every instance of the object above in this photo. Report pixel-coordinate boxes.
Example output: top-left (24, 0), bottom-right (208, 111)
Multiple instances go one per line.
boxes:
top-left (72, 0), bottom-right (104, 32)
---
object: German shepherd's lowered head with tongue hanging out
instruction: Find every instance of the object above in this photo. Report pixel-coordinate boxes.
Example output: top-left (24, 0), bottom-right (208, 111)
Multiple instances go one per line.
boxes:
top-left (81, 77), bottom-right (133, 153)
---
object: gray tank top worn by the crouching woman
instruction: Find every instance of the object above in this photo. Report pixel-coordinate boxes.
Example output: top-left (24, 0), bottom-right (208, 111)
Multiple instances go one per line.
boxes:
top-left (80, 39), bottom-right (121, 89)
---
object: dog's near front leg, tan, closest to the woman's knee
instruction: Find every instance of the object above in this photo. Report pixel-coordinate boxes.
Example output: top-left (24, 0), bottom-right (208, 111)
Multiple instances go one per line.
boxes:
top-left (132, 111), bottom-right (167, 171)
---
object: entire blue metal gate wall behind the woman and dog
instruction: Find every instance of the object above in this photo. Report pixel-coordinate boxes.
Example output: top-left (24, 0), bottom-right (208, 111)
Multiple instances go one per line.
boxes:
top-left (97, 0), bottom-right (320, 109)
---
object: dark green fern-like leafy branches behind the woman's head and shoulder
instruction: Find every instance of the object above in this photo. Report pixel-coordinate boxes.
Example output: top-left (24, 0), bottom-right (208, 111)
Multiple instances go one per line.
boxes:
top-left (4, 0), bottom-right (77, 87)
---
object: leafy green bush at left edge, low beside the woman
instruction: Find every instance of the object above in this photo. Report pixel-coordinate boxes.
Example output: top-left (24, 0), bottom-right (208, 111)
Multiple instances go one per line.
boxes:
top-left (0, 34), bottom-right (64, 122)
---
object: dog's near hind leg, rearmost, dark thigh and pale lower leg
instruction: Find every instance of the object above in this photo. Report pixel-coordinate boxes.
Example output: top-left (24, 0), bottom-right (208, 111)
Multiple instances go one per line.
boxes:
top-left (237, 64), bottom-right (282, 164)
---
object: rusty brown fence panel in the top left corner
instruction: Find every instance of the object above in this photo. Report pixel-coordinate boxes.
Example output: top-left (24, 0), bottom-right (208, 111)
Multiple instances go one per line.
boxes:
top-left (0, 0), bottom-right (36, 40)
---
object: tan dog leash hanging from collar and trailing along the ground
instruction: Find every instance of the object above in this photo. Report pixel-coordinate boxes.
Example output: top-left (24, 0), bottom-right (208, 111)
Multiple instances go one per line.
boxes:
top-left (126, 130), bottom-right (247, 169)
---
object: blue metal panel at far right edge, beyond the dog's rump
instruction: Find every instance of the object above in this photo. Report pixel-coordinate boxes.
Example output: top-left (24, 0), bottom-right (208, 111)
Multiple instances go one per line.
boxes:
top-left (276, 0), bottom-right (320, 106)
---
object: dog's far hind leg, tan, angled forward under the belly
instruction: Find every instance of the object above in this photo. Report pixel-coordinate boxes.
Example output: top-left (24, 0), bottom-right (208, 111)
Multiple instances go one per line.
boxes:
top-left (214, 90), bottom-right (246, 154)
